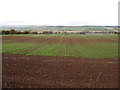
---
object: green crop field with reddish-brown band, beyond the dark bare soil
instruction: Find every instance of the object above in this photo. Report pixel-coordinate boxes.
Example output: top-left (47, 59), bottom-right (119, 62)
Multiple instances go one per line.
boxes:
top-left (1, 35), bottom-right (118, 58)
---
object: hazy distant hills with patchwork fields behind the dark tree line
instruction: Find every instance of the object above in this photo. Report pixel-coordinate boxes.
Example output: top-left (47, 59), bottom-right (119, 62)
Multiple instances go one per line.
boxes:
top-left (0, 25), bottom-right (120, 31)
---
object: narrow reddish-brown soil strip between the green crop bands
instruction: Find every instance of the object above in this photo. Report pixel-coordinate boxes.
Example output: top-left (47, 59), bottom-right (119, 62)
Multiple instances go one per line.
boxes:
top-left (2, 36), bottom-right (118, 44)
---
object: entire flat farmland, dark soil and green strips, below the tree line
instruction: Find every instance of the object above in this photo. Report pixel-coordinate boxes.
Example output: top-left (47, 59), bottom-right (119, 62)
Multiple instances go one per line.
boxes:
top-left (1, 35), bottom-right (118, 88)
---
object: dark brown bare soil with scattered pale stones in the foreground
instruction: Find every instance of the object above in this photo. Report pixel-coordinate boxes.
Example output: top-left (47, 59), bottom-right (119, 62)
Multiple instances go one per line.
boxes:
top-left (2, 54), bottom-right (118, 88)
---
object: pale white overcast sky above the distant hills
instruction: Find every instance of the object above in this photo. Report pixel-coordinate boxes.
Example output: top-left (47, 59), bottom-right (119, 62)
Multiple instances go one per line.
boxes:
top-left (0, 0), bottom-right (120, 25)
